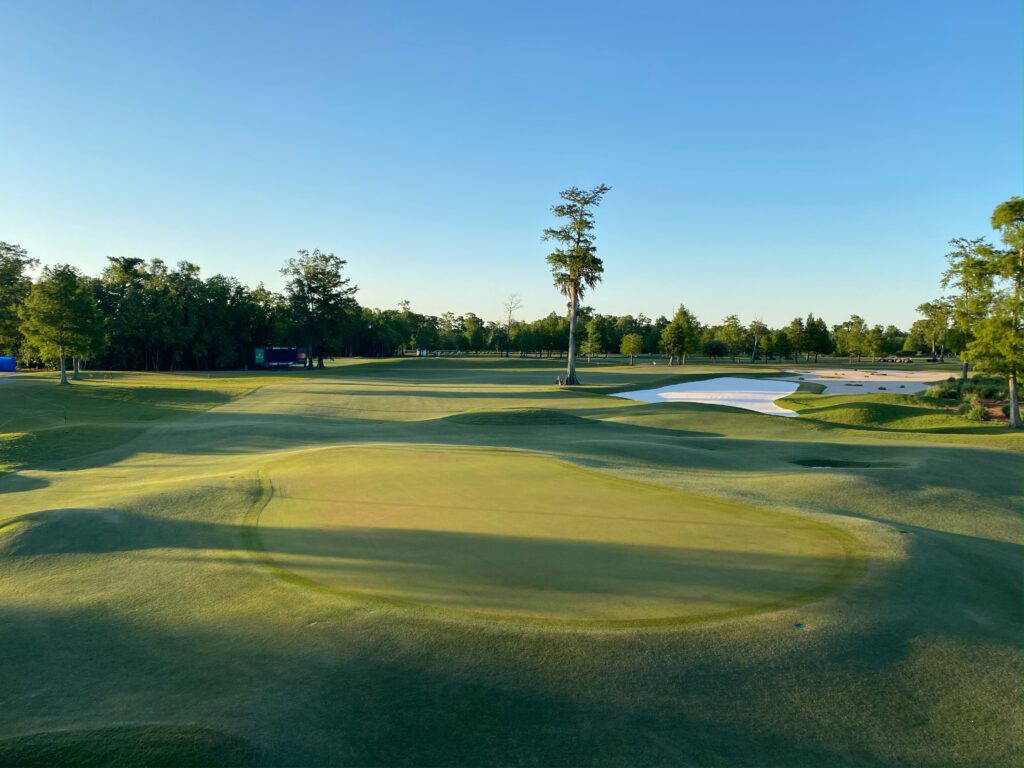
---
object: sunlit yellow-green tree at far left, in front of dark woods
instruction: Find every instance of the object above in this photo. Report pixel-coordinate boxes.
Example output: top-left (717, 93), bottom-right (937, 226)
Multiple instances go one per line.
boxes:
top-left (18, 264), bottom-right (99, 384)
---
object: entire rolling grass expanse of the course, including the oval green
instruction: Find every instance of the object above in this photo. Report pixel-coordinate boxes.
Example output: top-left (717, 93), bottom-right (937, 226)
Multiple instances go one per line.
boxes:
top-left (0, 359), bottom-right (1024, 766)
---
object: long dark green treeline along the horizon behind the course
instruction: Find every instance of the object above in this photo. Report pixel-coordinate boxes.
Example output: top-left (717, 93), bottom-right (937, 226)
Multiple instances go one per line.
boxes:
top-left (0, 243), bottom-right (929, 371)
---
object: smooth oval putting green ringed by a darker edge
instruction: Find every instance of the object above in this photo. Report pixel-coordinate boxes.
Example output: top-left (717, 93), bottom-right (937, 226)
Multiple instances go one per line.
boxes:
top-left (254, 447), bottom-right (859, 626)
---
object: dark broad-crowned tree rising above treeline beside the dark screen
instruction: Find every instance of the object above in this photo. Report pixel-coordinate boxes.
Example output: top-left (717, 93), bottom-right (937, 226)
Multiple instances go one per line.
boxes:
top-left (281, 250), bottom-right (357, 368)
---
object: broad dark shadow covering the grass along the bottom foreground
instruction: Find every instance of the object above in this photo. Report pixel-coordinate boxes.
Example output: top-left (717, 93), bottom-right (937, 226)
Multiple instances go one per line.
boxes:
top-left (0, 607), bottom-right (878, 768)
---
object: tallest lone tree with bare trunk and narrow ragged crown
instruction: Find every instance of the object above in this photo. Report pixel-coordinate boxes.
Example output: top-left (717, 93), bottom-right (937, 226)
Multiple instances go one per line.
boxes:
top-left (544, 184), bottom-right (611, 384)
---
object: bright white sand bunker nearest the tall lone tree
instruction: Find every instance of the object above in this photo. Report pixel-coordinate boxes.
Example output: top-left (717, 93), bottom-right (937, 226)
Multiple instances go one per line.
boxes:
top-left (613, 376), bottom-right (800, 416)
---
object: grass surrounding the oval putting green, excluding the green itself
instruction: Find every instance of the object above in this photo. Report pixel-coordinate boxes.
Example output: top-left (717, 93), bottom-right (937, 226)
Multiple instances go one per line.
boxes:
top-left (0, 359), bottom-right (1024, 766)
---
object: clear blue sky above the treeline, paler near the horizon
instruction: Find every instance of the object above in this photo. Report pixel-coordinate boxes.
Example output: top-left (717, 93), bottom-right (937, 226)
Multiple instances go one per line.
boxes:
top-left (0, 0), bottom-right (1024, 326)
